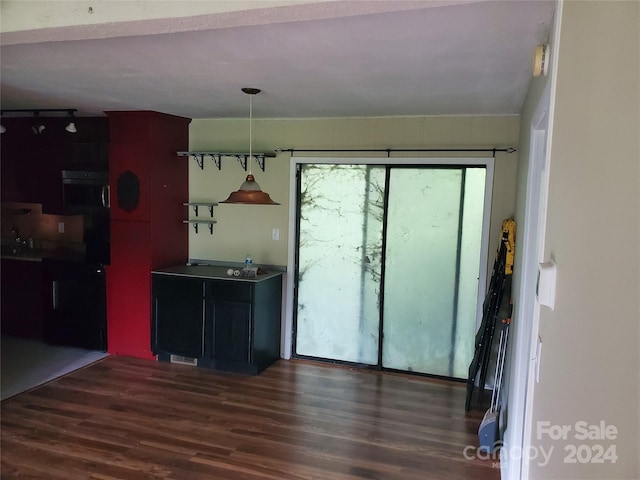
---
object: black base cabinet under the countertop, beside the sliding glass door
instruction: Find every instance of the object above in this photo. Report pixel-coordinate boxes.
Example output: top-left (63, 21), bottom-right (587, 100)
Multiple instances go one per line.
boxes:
top-left (152, 273), bottom-right (282, 374)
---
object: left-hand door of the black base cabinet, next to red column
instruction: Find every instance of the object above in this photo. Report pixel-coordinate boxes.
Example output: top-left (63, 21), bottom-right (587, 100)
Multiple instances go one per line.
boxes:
top-left (152, 275), bottom-right (205, 357)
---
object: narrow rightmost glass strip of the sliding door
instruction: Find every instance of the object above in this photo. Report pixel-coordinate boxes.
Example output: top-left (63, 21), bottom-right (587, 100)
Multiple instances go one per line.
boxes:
top-left (452, 168), bottom-right (486, 378)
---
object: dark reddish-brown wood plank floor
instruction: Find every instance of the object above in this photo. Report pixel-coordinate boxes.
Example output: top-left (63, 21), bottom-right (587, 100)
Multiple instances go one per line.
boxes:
top-left (0, 357), bottom-right (500, 480)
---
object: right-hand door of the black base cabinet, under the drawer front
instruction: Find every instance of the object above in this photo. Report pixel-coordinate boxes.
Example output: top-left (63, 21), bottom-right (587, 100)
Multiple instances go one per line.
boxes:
top-left (218, 301), bottom-right (251, 363)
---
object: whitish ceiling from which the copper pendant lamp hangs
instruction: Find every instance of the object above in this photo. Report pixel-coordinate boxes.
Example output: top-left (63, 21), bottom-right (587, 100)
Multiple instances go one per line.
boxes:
top-left (0, 0), bottom-right (555, 118)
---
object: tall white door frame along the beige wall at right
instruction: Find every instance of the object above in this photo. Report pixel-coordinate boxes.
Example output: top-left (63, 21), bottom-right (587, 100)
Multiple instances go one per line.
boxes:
top-left (501, 0), bottom-right (563, 480)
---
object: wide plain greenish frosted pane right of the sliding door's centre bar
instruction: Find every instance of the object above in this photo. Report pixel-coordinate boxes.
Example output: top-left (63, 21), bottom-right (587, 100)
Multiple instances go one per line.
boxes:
top-left (382, 168), bottom-right (462, 376)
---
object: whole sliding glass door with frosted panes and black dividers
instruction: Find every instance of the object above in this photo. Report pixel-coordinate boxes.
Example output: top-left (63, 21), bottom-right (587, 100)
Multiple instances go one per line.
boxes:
top-left (294, 164), bottom-right (486, 378)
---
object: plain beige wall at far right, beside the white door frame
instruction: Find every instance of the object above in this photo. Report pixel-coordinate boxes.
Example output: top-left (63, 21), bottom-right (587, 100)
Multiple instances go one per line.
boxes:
top-left (530, 1), bottom-right (640, 479)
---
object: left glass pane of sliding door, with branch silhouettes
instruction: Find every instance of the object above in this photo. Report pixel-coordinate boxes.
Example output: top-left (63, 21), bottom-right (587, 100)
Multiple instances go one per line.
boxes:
top-left (296, 165), bottom-right (385, 365)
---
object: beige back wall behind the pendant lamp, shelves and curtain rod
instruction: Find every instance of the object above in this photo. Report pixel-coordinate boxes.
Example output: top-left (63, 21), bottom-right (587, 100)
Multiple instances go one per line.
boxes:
top-left (189, 115), bottom-right (519, 265)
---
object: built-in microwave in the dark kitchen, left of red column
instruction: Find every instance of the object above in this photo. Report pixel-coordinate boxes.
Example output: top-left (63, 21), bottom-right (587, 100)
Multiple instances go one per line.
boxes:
top-left (62, 170), bottom-right (110, 213)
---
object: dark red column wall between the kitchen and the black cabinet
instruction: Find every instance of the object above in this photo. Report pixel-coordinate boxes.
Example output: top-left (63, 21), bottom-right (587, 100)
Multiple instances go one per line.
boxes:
top-left (106, 111), bottom-right (191, 359)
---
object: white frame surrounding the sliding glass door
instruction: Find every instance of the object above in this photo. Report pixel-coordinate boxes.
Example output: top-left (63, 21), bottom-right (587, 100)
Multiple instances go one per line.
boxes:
top-left (282, 155), bottom-right (495, 360)
